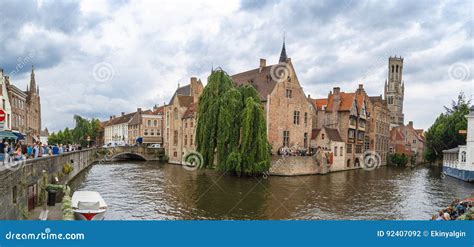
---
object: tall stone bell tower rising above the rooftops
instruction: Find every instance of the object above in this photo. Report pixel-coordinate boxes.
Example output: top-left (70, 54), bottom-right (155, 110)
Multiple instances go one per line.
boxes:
top-left (384, 56), bottom-right (405, 127)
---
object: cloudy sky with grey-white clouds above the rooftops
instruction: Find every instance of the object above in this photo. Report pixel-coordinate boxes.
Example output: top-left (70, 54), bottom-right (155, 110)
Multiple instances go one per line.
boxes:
top-left (0, 0), bottom-right (474, 130)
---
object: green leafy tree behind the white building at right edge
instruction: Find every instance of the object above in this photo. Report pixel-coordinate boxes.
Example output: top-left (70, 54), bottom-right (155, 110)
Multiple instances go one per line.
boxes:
top-left (424, 92), bottom-right (471, 162)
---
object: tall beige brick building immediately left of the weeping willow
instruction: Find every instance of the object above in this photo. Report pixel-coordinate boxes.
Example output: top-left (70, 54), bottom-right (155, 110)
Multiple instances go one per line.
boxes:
top-left (163, 77), bottom-right (204, 164)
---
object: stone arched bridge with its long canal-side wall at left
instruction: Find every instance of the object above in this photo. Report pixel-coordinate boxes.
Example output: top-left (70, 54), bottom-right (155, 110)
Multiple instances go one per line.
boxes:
top-left (0, 147), bottom-right (166, 220)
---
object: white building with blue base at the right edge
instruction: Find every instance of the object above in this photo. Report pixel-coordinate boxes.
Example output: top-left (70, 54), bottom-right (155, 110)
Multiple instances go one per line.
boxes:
top-left (443, 105), bottom-right (474, 182)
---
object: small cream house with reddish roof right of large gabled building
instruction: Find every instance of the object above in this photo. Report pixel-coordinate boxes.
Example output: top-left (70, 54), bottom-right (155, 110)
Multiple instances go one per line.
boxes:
top-left (311, 127), bottom-right (346, 171)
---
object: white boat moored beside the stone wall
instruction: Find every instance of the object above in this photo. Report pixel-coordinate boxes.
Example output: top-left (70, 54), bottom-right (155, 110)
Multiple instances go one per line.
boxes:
top-left (71, 191), bottom-right (107, 220)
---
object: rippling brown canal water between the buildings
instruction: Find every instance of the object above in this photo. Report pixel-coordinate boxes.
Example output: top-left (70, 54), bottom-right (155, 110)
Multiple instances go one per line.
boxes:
top-left (71, 161), bottom-right (474, 220)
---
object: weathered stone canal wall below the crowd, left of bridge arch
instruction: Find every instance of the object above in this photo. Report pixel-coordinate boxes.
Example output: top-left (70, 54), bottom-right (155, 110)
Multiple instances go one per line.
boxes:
top-left (0, 149), bottom-right (99, 220)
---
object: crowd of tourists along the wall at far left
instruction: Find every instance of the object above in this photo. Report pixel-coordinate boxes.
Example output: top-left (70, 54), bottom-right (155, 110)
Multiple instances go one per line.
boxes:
top-left (0, 140), bottom-right (81, 161)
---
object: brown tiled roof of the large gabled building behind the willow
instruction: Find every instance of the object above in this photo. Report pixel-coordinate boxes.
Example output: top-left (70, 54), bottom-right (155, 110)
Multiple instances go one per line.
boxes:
top-left (231, 65), bottom-right (277, 101)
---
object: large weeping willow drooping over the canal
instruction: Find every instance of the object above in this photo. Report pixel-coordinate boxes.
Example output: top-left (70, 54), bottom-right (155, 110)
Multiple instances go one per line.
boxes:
top-left (196, 69), bottom-right (270, 176)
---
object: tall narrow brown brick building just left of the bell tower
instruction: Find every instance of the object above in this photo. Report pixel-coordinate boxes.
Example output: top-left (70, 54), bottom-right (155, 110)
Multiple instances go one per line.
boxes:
top-left (368, 95), bottom-right (390, 165)
